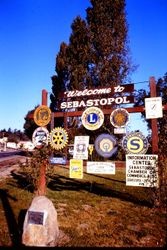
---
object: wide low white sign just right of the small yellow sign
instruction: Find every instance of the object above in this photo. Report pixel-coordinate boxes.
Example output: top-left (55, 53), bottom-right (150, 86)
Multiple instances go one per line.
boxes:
top-left (87, 161), bottom-right (115, 174)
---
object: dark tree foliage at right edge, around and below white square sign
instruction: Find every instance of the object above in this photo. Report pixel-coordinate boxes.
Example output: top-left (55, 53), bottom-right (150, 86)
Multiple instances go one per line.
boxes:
top-left (135, 73), bottom-right (167, 207)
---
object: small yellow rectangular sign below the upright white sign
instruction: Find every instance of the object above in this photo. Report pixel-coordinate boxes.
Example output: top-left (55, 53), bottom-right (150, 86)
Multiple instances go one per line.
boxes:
top-left (70, 159), bottom-right (83, 179)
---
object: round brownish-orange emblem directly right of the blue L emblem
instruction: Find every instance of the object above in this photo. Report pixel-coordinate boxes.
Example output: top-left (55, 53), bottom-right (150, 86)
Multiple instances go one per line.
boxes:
top-left (110, 108), bottom-right (129, 127)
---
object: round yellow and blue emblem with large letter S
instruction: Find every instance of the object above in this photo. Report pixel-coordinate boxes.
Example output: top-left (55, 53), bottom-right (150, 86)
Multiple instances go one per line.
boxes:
top-left (122, 132), bottom-right (148, 154)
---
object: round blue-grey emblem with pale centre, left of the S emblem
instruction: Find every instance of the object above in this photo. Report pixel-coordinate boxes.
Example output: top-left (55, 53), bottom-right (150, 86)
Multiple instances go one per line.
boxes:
top-left (95, 134), bottom-right (117, 158)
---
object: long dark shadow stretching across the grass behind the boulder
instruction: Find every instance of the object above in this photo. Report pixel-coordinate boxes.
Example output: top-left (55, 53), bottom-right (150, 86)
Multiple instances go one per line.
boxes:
top-left (11, 171), bottom-right (153, 207)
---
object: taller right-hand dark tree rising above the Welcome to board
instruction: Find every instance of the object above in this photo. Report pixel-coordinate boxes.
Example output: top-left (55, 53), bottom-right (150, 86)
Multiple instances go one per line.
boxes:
top-left (87, 0), bottom-right (133, 86)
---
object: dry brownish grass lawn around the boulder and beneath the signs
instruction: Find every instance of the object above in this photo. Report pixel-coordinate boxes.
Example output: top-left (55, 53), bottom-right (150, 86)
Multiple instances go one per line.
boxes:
top-left (0, 163), bottom-right (166, 247)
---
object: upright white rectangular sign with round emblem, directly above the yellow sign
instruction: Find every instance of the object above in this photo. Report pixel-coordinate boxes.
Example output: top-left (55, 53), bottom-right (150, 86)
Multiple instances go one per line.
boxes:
top-left (73, 136), bottom-right (89, 160)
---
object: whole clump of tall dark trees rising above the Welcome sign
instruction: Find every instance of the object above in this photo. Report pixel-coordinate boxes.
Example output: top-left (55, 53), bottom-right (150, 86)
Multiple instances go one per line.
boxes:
top-left (50, 0), bottom-right (133, 108)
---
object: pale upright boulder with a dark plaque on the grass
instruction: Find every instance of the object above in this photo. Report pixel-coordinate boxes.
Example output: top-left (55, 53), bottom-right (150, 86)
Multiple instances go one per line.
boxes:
top-left (22, 196), bottom-right (59, 246)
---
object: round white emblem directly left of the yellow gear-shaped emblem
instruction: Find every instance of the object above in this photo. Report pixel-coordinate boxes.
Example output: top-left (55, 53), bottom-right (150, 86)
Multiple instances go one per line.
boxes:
top-left (32, 127), bottom-right (49, 148)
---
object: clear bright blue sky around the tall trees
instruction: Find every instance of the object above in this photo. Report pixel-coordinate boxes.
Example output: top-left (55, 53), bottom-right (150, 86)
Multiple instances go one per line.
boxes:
top-left (0, 0), bottom-right (167, 135)
